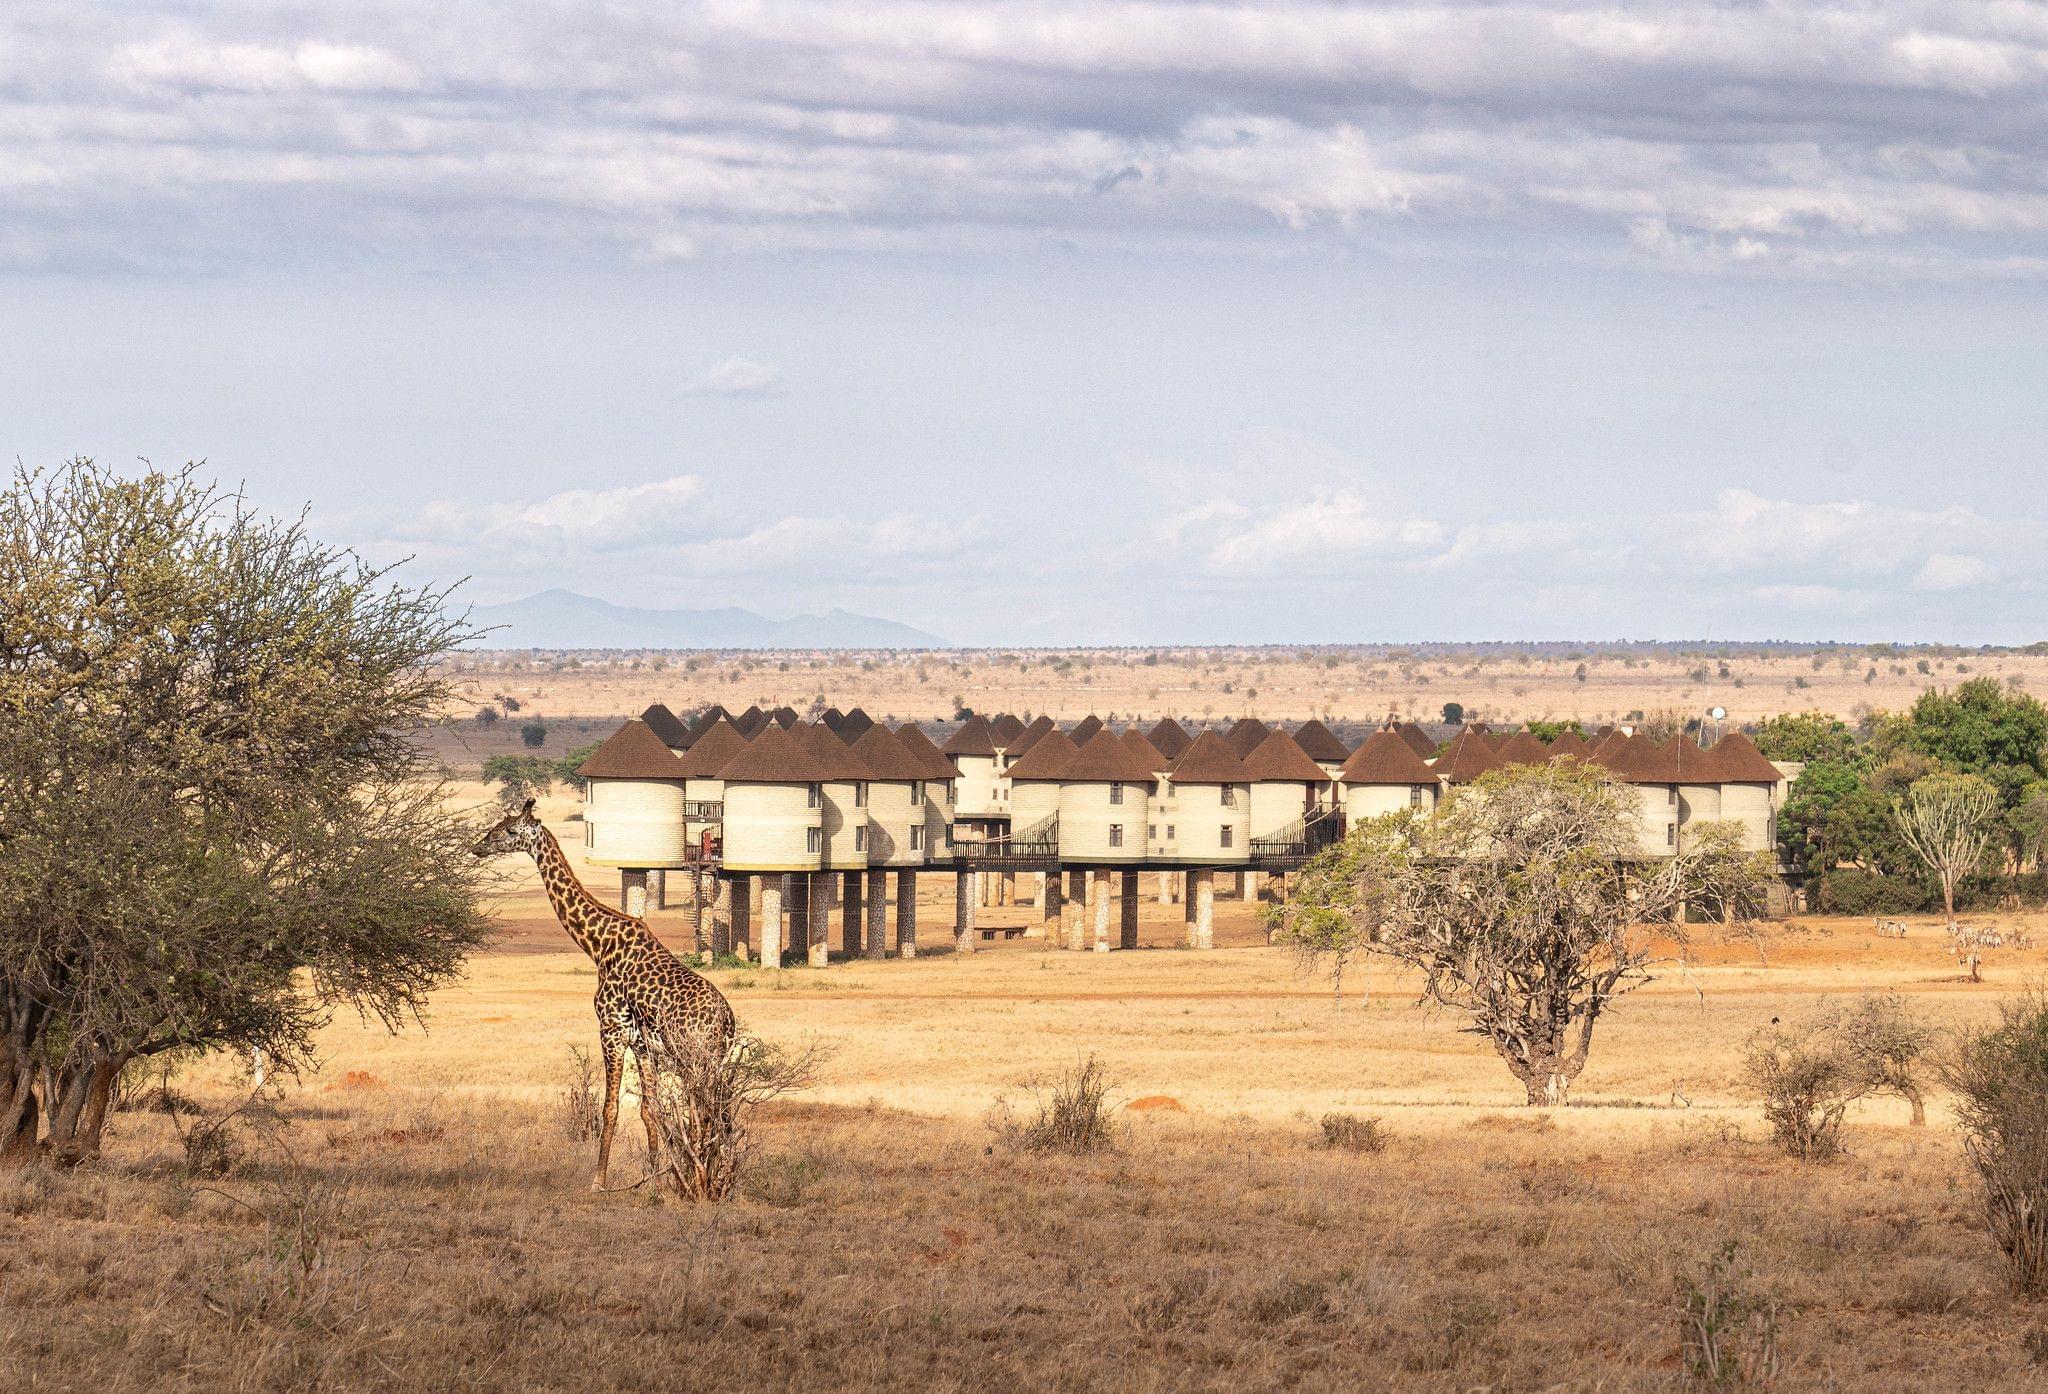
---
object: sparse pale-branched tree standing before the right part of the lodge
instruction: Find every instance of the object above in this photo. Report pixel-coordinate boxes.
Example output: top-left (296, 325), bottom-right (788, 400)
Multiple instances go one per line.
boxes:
top-left (1282, 761), bottom-right (1761, 1105)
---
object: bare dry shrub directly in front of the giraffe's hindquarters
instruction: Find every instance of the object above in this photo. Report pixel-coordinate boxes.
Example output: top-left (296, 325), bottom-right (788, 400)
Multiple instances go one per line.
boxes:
top-left (641, 1036), bottom-right (825, 1202)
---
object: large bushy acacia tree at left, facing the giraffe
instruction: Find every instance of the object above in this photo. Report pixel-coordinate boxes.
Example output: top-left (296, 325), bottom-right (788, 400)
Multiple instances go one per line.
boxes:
top-left (0, 461), bottom-right (487, 1163)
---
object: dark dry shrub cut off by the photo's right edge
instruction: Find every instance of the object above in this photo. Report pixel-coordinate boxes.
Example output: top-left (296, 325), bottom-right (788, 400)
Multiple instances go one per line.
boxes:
top-left (1944, 987), bottom-right (2048, 1296)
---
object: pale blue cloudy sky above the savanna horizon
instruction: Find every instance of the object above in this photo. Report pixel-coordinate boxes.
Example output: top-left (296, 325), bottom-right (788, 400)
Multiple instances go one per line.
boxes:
top-left (0, 0), bottom-right (2048, 645)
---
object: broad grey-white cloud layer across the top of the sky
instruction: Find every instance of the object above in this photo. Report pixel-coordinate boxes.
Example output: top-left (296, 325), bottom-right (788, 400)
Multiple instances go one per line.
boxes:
top-left (12, 0), bottom-right (2048, 278)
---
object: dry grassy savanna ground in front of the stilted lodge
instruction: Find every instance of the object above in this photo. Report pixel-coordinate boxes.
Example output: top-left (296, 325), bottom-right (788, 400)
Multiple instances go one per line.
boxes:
top-left (12, 822), bottom-right (2048, 1392)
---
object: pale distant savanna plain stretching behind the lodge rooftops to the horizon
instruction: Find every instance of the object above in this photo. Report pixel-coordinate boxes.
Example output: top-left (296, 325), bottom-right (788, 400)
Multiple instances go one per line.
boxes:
top-left (442, 645), bottom-right (2048, 770)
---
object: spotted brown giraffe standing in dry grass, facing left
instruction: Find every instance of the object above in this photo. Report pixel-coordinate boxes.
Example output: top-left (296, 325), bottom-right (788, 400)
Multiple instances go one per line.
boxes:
top-left (473, 798), bottom-right (733, 1191)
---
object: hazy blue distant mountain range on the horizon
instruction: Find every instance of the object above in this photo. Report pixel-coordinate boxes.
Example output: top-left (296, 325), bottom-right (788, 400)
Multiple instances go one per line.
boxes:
top-left (469, 590), bottom-right (948, 649)
